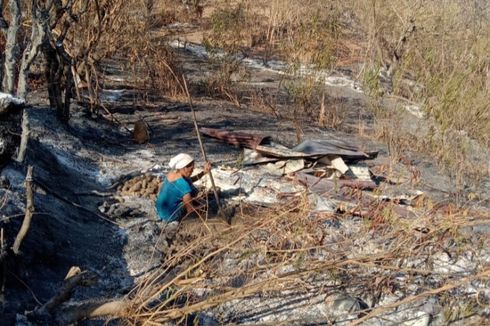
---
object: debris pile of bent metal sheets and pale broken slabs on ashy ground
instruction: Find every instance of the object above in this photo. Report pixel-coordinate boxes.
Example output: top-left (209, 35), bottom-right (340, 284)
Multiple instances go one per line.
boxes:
top-left (197, 128), bottom-right (378, 211)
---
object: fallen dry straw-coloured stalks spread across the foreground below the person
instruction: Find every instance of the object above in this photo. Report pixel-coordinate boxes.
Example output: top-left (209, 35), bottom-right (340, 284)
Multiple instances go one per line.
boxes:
top-left (119, 194), bottom-right (490, 325)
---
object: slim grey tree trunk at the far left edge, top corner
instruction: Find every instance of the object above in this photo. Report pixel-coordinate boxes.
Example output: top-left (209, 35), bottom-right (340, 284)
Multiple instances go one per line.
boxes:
top-left (2, 0), bottom-right (21, 94)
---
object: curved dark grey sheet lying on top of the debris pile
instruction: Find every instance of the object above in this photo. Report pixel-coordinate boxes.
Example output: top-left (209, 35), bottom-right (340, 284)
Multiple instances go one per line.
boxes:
top-left (291, 140), bottom-right (378, 160)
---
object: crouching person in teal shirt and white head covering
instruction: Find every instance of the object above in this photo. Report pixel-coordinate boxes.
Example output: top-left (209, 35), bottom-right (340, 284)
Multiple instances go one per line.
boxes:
top-left (156, 153), bottom-right (211, 226)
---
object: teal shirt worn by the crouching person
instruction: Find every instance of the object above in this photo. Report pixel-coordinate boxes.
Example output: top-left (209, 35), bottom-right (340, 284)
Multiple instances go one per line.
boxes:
top-left (156, 177), bottom-right (195, 222)
